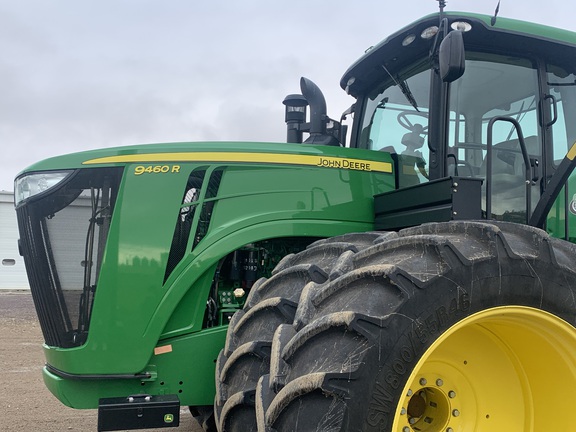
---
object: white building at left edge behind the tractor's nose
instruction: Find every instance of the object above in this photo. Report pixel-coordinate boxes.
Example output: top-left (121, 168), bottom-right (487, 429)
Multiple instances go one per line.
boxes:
top-left (0, 191), bottom-right (30, 289)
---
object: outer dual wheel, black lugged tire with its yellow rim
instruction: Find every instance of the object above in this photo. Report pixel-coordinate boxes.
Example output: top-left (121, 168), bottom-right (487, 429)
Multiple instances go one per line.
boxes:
top-left (252, 222), bottom-right (576, 432)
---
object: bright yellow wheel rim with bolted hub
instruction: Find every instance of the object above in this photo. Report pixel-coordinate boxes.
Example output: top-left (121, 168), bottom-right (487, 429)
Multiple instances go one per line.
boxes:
top-left (392, 306), bottom-right (576, 432)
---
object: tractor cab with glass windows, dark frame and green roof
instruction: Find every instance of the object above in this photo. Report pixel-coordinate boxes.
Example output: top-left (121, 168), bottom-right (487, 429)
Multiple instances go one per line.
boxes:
top-left (341, 13), bottom-right (576, 238)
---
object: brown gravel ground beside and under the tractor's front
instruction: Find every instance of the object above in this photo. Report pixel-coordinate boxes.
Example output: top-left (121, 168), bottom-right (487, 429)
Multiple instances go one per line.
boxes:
top-left (0, 290), bottom-right (202, 432)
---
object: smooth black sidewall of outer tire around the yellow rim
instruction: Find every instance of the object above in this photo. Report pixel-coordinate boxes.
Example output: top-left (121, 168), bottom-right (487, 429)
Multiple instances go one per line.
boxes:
top-left (358, 258), bottom-right (576, 431)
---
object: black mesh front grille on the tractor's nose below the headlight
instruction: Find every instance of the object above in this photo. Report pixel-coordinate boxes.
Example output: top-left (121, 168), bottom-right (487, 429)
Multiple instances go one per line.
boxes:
top-left (16, 168), bottom-right (122, 348)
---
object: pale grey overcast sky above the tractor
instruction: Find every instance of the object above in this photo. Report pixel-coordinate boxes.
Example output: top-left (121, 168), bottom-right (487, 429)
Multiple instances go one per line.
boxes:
top-left (0, 0), bottom-right (576, 190)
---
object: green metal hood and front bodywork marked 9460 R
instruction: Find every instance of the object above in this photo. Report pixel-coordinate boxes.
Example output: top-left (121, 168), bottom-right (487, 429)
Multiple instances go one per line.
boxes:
top-left (25, 143), bottom-right (394, 408)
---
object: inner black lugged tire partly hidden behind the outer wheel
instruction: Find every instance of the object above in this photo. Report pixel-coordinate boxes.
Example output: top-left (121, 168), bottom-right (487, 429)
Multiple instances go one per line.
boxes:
top-left (214, 233), bottom-right (395, 432)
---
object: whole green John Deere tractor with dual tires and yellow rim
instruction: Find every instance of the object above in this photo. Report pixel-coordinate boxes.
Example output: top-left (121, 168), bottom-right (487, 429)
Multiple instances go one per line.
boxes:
top-left (15, 2), bottom-right (576, 432)
